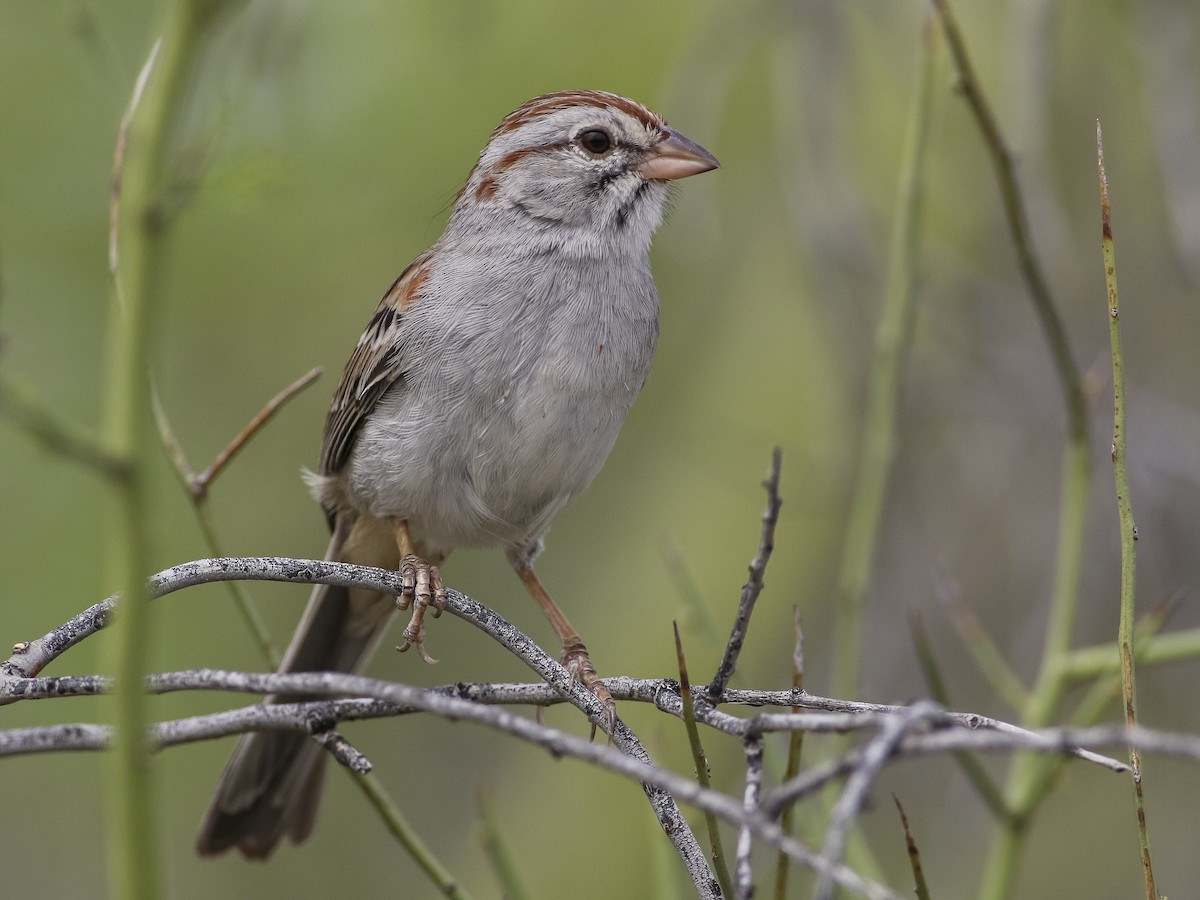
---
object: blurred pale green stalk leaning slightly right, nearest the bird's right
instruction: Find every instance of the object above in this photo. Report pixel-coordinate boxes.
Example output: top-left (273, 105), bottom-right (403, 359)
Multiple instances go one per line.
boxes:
top-left (833, 15), bottom-right (937, 697)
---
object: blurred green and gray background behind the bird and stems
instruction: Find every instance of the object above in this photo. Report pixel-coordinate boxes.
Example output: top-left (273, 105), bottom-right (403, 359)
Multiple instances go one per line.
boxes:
top-left (0, 0), bottom-right (1200, 898)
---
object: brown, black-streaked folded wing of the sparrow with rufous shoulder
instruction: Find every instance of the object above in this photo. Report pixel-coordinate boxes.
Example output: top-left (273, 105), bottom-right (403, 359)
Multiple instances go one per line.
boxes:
top-left (319, 252), bottom-right (430, 475)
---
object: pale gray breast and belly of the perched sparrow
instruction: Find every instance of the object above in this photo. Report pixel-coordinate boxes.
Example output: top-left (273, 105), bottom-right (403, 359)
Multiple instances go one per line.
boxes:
top-left (343, 248), bottom-right (658, 550)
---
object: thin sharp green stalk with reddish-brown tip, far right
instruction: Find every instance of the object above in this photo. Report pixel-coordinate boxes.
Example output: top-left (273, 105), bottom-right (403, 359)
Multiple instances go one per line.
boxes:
top-left (1096, 121), bottom-right (1158, 900)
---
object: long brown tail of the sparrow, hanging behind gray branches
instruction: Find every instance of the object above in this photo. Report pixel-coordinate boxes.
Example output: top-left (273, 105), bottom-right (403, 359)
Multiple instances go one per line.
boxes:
top-left (196, 518), bottom-right (398, 859)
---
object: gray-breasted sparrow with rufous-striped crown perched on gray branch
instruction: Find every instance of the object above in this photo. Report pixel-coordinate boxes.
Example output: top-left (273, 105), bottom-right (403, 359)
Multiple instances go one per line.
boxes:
top-left (197, 91), bottom-right (718, 858)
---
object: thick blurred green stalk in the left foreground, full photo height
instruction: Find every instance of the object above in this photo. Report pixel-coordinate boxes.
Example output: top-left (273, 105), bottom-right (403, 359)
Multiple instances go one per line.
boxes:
top-left (102, 2), bottom-right (230, 900)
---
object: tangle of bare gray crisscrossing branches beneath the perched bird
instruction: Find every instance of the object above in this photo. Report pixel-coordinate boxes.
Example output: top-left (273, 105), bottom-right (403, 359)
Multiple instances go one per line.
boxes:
top-left (0, 557), bottom-right (1152, 896)
